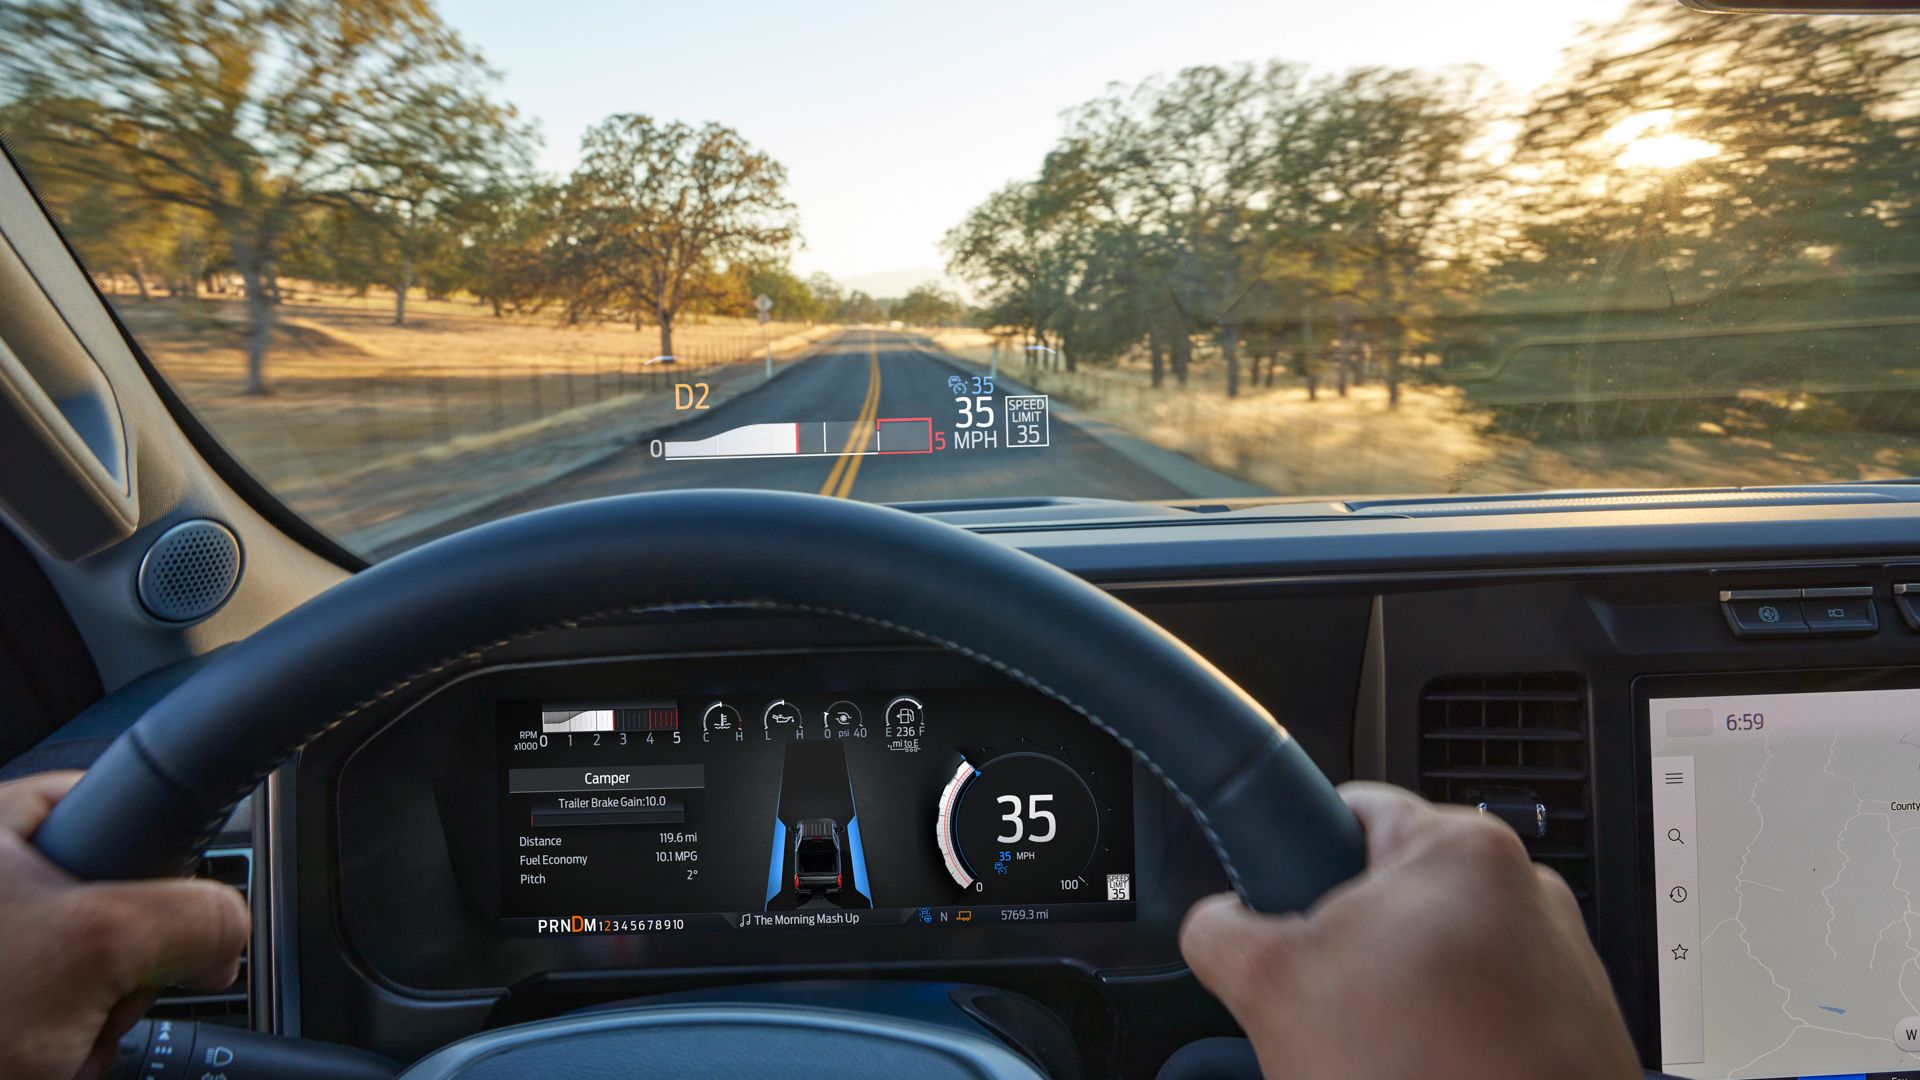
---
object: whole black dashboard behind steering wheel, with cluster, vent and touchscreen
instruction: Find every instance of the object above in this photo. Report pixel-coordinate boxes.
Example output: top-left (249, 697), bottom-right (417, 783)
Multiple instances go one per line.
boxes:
top-left (243, 495), bottom-right (1920, 1080)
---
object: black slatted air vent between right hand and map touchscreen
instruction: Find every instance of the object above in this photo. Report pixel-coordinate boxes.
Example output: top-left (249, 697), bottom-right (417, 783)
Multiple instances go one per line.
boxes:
top-left (1421, 675), bottom-right (1594, 930)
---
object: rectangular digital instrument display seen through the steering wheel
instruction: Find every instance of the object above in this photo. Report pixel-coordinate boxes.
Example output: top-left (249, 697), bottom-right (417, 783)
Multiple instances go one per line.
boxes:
top-left (497, 688), bottom-right (1137, 934)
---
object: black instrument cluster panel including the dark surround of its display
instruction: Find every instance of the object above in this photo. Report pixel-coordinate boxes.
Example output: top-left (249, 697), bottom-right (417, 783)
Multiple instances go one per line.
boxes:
top-left (315, 638), bottom-right (1225, 994)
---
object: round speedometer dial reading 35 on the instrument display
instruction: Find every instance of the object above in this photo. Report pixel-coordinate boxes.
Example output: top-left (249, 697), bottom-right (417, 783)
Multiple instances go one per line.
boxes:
top-left (933, 749), bottom-right (1100, 891)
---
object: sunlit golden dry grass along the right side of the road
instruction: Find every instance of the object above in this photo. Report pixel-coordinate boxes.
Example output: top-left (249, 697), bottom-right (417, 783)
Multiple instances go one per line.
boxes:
top-left (929, 331), bottom-right (1916, 494)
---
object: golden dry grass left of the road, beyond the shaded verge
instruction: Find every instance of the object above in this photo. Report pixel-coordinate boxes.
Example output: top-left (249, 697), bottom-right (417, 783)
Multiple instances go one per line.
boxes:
top-left (115, 290), bottom-right (820, 488)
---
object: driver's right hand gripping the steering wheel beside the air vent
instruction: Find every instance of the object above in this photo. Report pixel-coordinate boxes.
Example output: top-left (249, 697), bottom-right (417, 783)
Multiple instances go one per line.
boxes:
top-left (1181, 784), bottom-right (1642, 1080)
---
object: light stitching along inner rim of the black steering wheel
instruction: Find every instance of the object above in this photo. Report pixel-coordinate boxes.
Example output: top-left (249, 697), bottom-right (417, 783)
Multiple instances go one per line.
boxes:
top-left (183, 600), bottom-right (1246, 899)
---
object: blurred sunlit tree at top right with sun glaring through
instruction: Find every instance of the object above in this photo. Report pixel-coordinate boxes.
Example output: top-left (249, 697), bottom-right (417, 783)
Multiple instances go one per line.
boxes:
top-left (1501, 0), bottom-right (1920, 297)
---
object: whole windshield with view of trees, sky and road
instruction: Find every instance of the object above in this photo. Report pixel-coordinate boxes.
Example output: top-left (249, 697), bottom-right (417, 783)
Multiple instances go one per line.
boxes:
top-left (0, 0), bottom-right (1920, 557)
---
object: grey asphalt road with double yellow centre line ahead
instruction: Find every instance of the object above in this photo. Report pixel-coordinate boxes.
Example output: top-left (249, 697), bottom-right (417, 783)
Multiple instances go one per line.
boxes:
top-left (464, 331), bottom-right (1219, 517)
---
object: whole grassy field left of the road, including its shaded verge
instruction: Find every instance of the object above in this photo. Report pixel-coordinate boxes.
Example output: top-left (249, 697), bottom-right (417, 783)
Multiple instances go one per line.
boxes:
top-left (113, 290), bottom-right (835, 538)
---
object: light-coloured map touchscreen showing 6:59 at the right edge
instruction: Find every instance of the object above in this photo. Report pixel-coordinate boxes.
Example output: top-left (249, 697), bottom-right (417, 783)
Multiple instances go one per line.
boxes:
top-left (1645, 680), bottom-right (1920, 1078)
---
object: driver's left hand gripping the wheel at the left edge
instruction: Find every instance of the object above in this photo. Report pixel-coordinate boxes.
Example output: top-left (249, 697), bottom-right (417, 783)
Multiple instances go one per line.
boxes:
top-left (0, 773), bottom-right (248, 1080)
